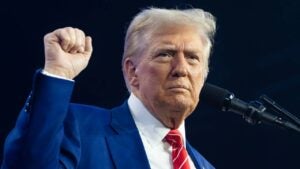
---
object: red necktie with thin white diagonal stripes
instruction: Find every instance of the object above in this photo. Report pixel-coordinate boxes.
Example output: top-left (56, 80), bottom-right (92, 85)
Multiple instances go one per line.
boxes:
top-left (165, 130), bottom-right (190, 169)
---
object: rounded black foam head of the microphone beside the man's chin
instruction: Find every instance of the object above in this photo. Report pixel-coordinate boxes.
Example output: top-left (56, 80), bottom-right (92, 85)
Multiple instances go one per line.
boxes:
top-left (200, 83), bottom-right (234, 111)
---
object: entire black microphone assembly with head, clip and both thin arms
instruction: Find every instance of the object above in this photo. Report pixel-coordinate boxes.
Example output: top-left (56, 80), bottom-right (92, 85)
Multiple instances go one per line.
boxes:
top-left (201, 83), bottom-right (300, 133)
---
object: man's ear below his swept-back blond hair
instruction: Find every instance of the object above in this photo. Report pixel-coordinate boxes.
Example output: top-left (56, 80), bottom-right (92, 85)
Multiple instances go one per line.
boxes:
top-left (124, 57), bottom-right (139, 87)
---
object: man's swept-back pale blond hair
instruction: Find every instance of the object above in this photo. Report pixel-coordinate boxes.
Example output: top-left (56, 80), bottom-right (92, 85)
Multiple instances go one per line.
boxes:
top-left (122, 8), bottom-right (216, 89)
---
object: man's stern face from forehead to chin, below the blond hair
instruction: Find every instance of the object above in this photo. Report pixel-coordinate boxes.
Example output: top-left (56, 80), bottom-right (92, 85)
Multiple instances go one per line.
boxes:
top-left (130, 27), bottom-right (207, 128)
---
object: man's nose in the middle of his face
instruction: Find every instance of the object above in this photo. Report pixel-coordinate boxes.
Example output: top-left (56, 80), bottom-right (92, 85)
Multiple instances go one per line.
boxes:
top-left (172, 54), bottom-right (188, 77)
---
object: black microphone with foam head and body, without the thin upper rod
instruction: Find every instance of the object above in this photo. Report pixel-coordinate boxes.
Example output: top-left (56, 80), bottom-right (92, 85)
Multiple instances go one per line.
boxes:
top-left (200, 83), bottom-right (300, 132)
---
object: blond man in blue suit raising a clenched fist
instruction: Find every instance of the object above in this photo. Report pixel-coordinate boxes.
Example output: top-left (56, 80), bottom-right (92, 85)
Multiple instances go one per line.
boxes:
top-left (2, 8), bottom-right (215, 169)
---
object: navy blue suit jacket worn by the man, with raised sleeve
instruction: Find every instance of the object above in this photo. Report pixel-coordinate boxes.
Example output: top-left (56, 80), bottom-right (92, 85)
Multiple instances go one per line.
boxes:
top-left (1, 73), bottom-right (213, 169)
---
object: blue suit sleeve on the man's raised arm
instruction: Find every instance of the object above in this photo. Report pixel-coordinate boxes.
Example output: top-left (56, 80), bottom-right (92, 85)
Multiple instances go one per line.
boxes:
top-left (1, 71), bottom-right (80, 169)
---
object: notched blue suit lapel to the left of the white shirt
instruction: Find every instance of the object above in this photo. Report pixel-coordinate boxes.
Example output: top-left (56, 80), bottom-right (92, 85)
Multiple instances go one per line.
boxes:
top-left (106, 102), bottom-right (150, 169)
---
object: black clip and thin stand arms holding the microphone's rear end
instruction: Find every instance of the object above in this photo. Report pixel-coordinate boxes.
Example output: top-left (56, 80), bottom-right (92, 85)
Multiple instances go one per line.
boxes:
top-left (237, 95), bottom-right (300, 133)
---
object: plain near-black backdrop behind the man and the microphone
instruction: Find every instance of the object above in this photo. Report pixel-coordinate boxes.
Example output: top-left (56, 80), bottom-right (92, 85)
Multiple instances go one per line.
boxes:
top-left (0, 0), bottom-right (300, 169)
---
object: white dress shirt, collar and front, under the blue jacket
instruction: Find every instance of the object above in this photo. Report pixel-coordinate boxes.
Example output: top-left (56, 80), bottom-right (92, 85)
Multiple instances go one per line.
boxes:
top-left (128, 93), bottom-right (195, 169)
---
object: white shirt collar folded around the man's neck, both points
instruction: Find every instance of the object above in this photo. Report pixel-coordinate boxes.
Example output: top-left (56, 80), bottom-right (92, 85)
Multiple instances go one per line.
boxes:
top-left (128, 93), bottom-right (186, 146)
